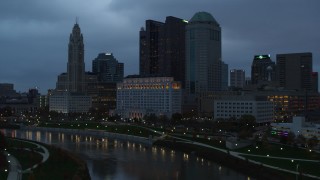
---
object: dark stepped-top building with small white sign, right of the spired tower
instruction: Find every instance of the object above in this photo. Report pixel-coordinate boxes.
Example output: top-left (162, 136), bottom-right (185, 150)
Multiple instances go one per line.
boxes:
top-left (92, 53), bottom-right (123, 83)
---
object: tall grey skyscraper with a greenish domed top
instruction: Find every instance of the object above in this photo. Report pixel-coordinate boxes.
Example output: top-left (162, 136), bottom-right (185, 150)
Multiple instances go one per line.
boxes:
top-left (186, 12), bottom-right (222, 94)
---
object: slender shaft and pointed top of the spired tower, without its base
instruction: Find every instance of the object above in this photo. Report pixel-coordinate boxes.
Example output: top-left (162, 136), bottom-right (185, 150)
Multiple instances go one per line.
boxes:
top-left (67, 22), bottom-right (85, 92)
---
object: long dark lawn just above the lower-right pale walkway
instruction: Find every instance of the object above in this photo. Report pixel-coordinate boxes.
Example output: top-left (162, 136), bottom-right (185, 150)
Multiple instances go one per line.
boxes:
top-left (235, 143), bottom-right (320, 160)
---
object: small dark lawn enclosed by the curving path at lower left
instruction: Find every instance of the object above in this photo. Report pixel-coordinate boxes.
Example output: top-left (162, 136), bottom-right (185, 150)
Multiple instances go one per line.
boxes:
top-left (7, 148), bottom-right (42, 170)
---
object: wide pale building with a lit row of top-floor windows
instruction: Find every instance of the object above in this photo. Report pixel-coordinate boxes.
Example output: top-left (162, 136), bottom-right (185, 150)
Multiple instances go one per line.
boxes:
top-left (117, 77), bottom-right (181, 118)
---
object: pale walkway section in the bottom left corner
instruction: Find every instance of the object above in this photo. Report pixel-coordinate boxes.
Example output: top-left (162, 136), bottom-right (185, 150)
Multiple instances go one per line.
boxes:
top-left (4, 151), bottom-right (22, 180)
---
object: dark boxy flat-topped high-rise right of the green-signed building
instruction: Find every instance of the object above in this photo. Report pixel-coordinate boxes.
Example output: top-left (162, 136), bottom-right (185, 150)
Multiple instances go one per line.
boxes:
top-left (277, 52), bottom-right (313, 90)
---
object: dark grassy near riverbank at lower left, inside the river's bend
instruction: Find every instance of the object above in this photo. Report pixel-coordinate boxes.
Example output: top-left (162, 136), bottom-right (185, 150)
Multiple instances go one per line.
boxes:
top-left (7, 138), bottom-right (91, 180)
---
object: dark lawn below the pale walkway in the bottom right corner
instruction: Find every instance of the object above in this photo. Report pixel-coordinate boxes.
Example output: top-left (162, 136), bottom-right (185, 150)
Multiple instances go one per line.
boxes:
top-left (243, 155), bottom-right (320, 177)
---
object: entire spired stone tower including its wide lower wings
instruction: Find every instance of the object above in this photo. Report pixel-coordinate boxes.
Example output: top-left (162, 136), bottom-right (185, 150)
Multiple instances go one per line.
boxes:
top-left (49, 22), bottom-right (91, 113)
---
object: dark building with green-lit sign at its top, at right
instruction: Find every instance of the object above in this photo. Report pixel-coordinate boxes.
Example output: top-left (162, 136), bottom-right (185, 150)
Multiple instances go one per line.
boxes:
top-left (251, 55), bottom-right (276, 84)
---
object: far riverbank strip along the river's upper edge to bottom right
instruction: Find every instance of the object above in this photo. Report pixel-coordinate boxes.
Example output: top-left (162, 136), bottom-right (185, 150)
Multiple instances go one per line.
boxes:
top-left (13, 127), bottom-right (318, 179)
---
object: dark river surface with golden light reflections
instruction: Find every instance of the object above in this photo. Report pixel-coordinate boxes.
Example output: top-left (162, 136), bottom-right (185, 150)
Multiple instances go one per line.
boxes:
top-left (2, 130), bottom-right (247, 180)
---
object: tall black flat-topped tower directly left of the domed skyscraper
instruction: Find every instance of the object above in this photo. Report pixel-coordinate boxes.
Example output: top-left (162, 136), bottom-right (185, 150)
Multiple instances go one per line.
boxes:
top-left (140, 16), bottom-right (187, 86)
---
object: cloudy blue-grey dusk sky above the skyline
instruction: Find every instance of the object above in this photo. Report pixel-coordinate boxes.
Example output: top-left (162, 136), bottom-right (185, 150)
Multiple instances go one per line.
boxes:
top-left (0, 0), bottom-right (320, 94)
